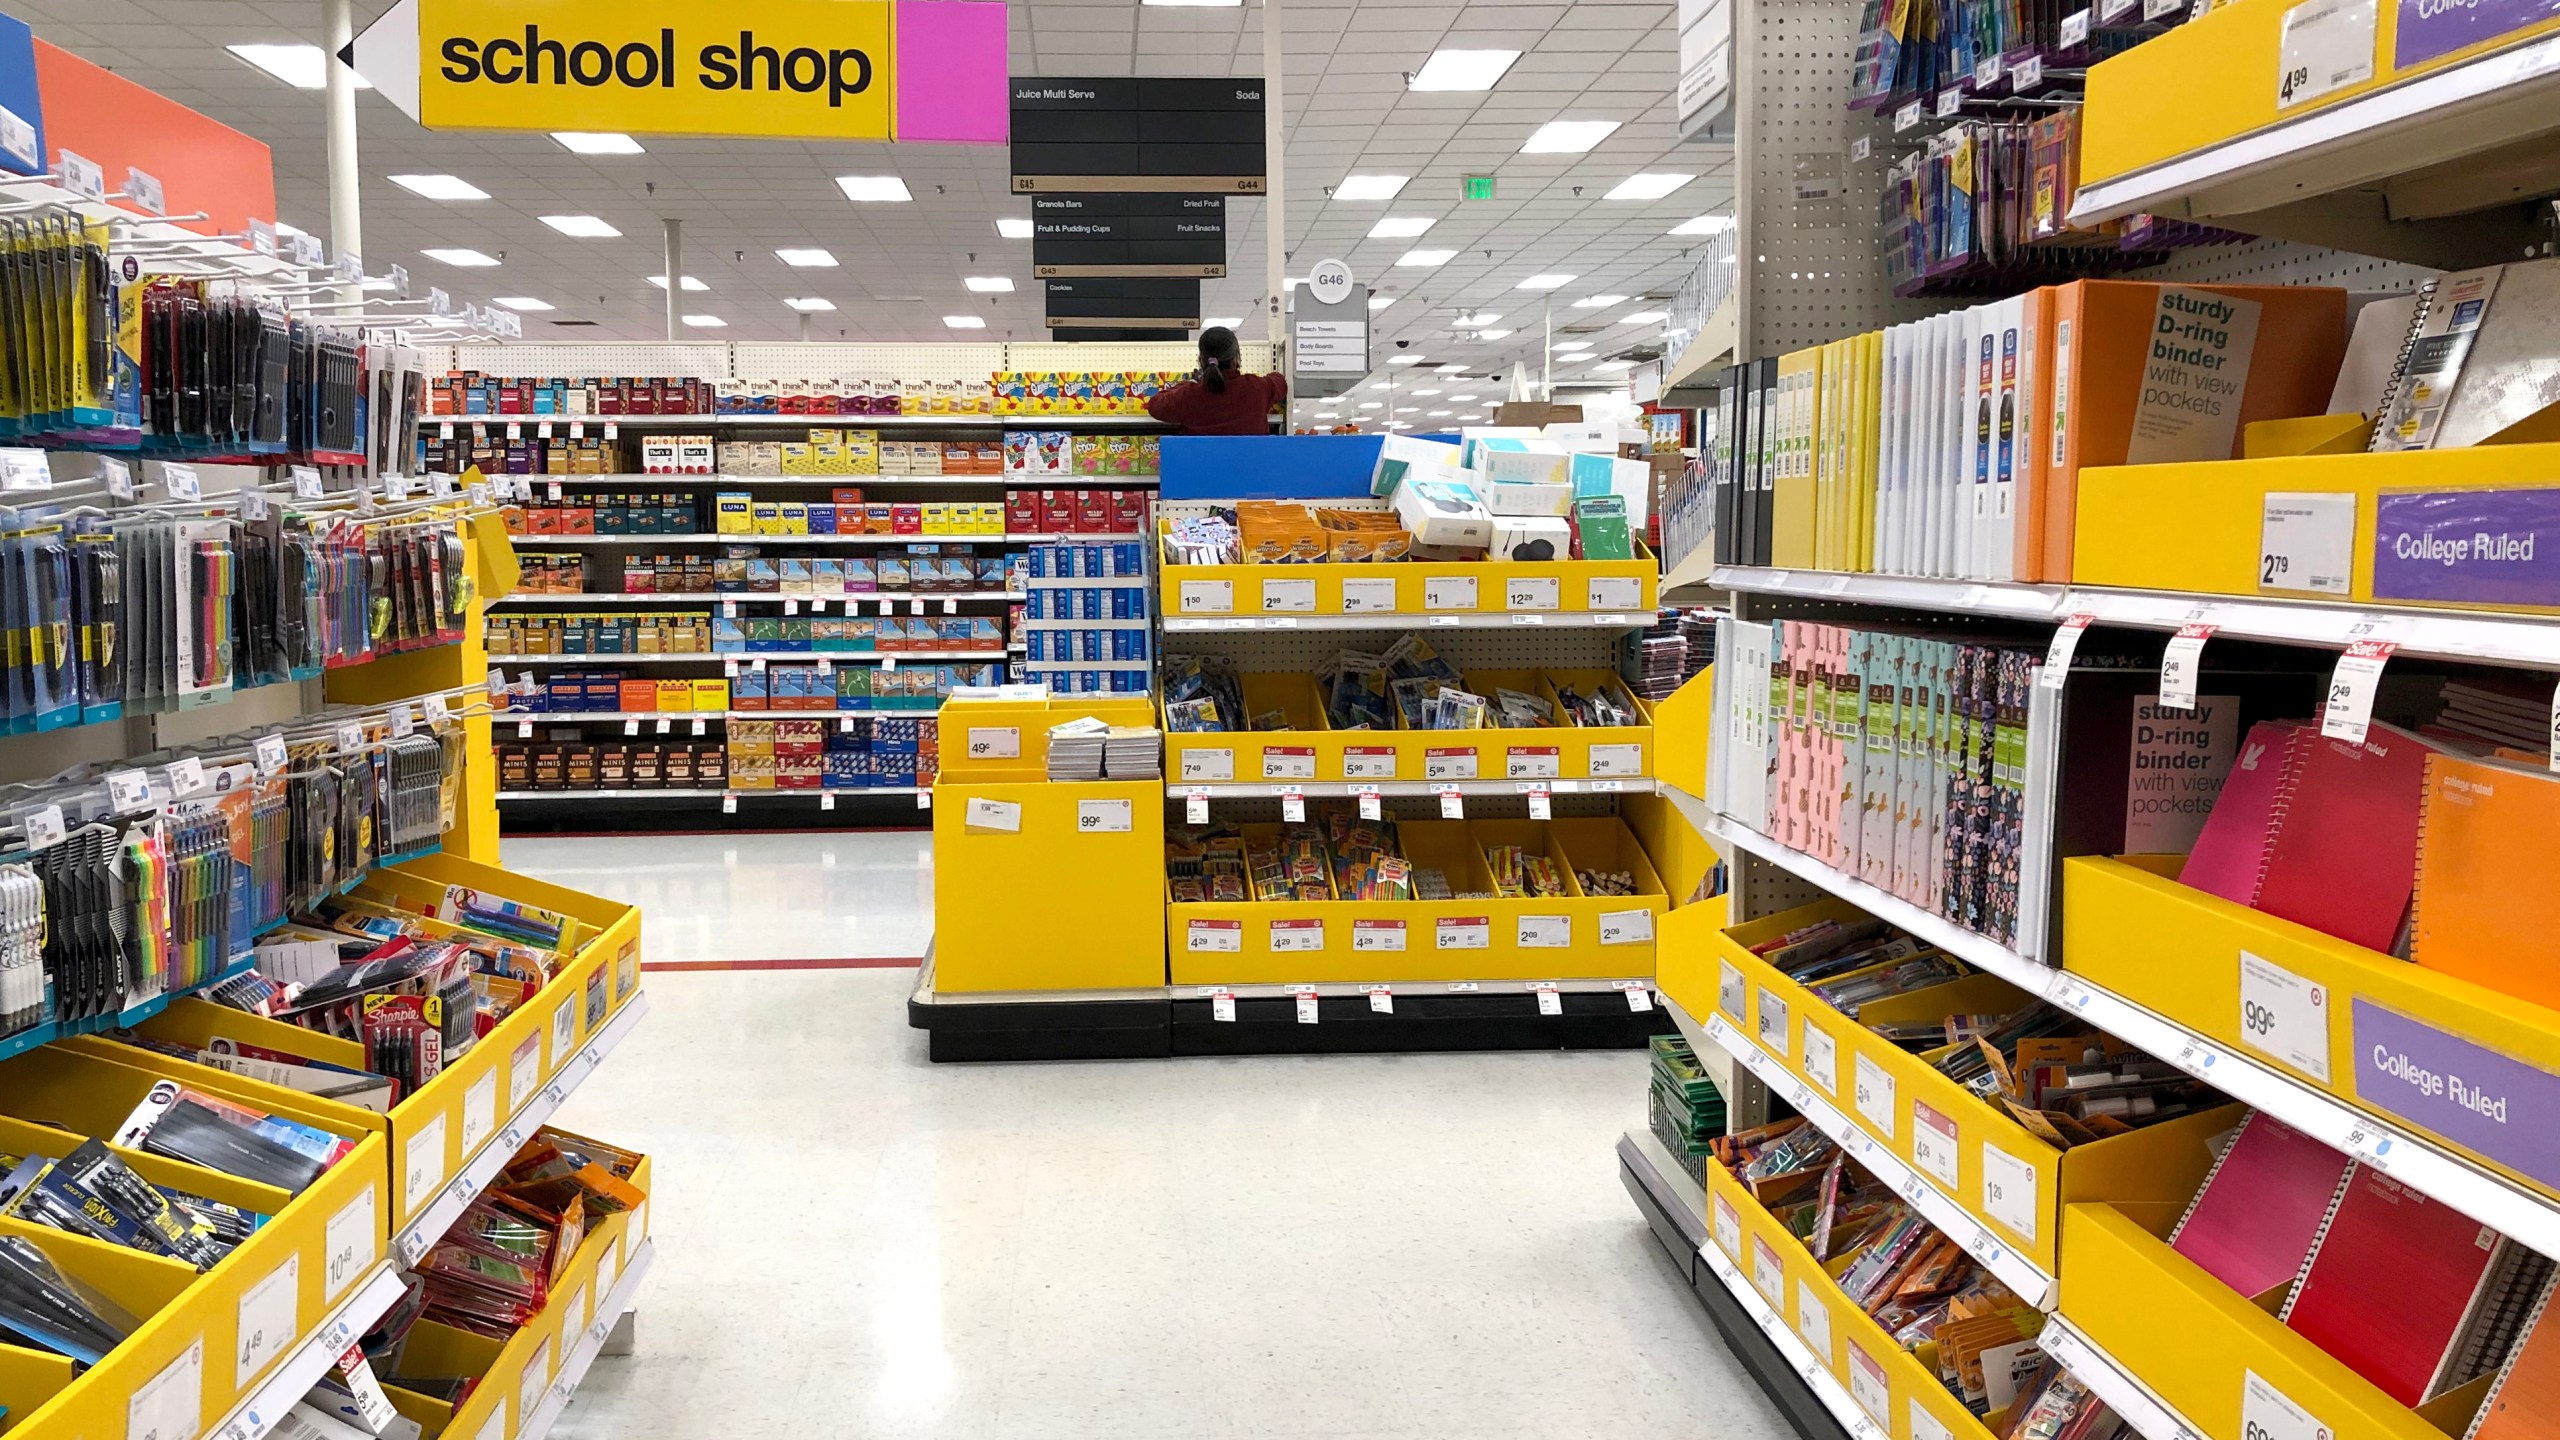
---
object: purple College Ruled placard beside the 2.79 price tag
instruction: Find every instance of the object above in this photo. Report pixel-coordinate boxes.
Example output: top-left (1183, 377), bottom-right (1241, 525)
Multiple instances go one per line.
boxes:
top-left (2373, 489), bottom-right (2560, 605)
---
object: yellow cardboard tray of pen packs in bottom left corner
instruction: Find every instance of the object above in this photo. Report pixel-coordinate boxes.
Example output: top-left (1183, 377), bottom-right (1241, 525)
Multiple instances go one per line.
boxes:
top-left (0, 1043), bottom-right (392, 1440)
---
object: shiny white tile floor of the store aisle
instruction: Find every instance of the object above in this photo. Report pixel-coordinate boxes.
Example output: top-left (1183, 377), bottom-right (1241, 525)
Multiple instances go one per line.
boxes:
top-left (507, 835), bottom-right (1784, 1440)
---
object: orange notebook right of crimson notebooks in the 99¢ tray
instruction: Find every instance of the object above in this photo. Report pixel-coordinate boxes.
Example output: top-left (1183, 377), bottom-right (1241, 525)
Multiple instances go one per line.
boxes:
top-left (2409, 753), bottom-right (2560, 1010)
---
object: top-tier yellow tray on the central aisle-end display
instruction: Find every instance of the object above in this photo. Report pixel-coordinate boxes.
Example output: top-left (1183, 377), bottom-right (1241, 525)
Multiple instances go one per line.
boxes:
top-left (1157, 520), bottom-right (1661, 620)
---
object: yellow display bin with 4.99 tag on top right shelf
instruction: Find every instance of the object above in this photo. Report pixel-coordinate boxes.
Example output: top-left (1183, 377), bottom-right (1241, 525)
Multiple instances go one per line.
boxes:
top-left (2079, 0), bottom-right (2560, 187)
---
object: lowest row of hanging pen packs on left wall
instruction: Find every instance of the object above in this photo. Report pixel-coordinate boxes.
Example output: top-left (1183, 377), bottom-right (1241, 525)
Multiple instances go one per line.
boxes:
top-left (0, 689), bottom-right (506, 1053)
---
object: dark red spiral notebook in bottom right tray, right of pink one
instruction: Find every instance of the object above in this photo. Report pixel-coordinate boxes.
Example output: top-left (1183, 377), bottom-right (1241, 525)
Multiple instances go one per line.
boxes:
top-left (2278, 1166), bottom-right (2550, 1407)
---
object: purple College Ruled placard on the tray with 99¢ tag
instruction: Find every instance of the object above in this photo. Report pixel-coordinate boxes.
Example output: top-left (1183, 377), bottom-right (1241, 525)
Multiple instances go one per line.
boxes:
top-left (2355, 999), bottom-right (2560, 1186)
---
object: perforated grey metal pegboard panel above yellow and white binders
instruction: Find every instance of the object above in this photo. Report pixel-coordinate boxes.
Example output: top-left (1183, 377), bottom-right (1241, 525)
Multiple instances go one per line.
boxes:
top-left (1736, 0), bottom-right (1948, 356)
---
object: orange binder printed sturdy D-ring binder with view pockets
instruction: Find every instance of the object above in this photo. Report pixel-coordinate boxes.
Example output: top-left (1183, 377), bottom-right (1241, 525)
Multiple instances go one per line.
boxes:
top-left (2017, 279), bottom-right (2348, 584)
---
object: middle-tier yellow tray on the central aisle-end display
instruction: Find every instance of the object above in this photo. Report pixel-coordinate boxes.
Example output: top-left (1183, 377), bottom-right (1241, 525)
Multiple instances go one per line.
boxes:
top-left (1165, 669), bottom-right (1654, 787)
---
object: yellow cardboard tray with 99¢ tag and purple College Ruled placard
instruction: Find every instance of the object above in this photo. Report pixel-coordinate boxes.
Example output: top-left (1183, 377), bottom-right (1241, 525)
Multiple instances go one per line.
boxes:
top-left (2063, 856), bottom-right (2560, 1199)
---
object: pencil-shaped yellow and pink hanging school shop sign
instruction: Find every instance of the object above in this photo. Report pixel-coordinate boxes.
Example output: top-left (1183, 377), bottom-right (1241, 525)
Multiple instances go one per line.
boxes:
top-left (338, 0), bottom-right (1006, 143)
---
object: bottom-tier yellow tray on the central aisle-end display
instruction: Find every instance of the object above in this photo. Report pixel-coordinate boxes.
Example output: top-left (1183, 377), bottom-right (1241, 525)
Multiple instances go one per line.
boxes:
top-left (1162, 815), bottom-right (1669, 986)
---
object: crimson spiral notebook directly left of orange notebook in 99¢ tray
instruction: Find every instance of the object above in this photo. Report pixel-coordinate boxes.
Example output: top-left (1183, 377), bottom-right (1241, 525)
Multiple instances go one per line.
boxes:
top-left (2258, 720), bottom-right (2437, 953)
